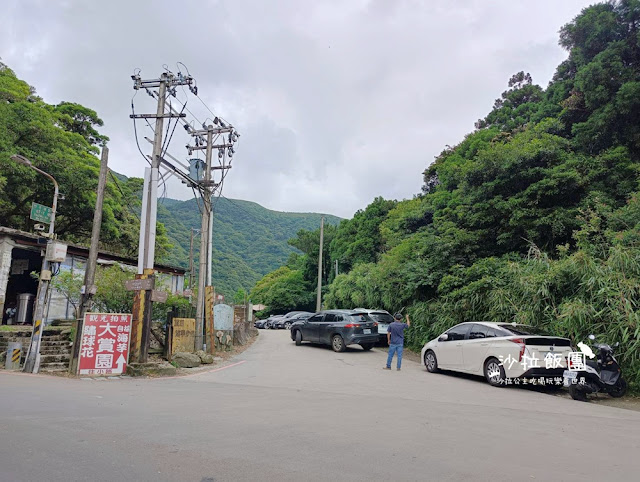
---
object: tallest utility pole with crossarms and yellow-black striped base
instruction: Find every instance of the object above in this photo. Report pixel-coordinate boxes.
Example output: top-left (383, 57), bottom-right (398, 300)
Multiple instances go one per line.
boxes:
top-left (130, 68), bottom-right (193, 362)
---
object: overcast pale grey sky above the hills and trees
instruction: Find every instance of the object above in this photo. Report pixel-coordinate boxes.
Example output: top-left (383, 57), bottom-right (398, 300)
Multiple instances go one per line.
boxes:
top-left (0, 0), bottom-right (594, 217)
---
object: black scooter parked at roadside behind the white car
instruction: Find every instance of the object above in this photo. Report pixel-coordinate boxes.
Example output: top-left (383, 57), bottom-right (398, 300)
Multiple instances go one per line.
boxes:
top-left (564, 335), bottom-right (627, 402)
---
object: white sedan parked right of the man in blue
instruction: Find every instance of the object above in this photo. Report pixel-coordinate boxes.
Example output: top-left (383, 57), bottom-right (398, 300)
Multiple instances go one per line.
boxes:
top-left (422, 321), bottom-right (573, 386)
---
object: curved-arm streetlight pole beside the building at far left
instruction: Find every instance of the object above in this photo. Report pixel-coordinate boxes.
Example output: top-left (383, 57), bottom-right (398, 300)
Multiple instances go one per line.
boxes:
top-left (11, 154), bottom-right (58, 373)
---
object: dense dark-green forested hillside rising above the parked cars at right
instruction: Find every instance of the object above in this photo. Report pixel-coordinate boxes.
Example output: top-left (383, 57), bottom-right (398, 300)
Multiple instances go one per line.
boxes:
top-left (252, 0), bottom-right (640, 389)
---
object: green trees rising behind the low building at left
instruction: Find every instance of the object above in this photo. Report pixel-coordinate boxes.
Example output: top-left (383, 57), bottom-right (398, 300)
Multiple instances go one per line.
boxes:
top-left (0, 62), bottom-right (168, 257)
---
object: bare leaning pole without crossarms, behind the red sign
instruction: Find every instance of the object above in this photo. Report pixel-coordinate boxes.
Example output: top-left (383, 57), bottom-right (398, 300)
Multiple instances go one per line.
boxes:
top-left (69, 146), bottom-right (109, 375)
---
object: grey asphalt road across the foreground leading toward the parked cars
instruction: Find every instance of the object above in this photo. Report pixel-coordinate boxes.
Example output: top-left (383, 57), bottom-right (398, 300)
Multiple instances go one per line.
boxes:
top-left (0, 331), bottom-right (640, 482)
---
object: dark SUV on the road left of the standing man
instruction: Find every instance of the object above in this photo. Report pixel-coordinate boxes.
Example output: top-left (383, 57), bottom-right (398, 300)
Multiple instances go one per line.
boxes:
top-left (291, 310), bottom-right (378, 352)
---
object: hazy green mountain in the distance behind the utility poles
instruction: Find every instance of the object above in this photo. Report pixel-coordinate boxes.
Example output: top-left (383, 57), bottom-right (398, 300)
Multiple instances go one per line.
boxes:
top-left (158, 197), bottom-right (340, 296)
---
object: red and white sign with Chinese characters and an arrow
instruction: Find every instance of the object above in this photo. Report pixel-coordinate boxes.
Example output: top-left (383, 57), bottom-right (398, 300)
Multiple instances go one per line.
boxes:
top-left (78, 313), bottom-right (131, 375)
